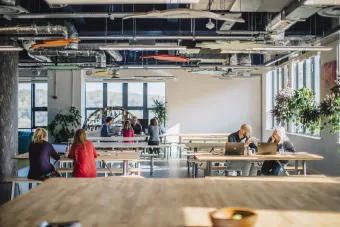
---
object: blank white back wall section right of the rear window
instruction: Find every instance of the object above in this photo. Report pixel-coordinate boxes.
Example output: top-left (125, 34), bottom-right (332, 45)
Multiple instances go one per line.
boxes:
top-left (166, 71), bottom-right (261, 137)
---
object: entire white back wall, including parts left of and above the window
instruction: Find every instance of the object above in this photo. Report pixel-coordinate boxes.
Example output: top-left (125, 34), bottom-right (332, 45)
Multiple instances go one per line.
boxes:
top-left (48, 70), bottom-right (261, 137)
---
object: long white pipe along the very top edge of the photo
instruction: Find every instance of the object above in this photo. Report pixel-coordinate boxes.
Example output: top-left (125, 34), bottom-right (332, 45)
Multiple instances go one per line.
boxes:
top-left (45, 0), bottom-right (200, 5)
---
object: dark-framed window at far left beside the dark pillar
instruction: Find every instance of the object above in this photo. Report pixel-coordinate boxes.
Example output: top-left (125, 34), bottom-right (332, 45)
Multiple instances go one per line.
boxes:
top-left (18, 83), bottom-right (48, 130)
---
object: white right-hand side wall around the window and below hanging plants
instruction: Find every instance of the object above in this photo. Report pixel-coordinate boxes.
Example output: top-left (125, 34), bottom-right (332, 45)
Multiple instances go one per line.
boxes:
top-left (262, 42), bottom-right (340, 176)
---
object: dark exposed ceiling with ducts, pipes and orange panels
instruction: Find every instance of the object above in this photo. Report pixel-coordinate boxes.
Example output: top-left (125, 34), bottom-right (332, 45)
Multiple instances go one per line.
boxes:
top-left (0, 0), bottom-right (337, 79)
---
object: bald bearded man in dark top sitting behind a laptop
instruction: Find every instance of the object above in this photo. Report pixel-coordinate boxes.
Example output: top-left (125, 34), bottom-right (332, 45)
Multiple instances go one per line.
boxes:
top-left (228, 124), bottom-right (257, 176)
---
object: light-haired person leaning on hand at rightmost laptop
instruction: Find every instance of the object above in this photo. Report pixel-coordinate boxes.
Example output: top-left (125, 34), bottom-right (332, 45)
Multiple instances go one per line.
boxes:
top-left (261, 126), bottom-right (295, 176)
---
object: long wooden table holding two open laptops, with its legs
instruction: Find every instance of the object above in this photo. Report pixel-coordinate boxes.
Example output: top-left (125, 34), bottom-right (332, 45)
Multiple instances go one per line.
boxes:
top-left (193, 152), bottom-right (324, 176)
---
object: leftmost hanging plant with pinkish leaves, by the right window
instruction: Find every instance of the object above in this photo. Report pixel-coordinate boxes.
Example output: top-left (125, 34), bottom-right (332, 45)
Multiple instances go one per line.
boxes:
top-left (271, 87), bottom-right (294, 124)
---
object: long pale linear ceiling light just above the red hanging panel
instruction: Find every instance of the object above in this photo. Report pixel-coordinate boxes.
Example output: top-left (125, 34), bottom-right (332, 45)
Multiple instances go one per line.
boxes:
top-left (98, 45), bottom-right (187, 51)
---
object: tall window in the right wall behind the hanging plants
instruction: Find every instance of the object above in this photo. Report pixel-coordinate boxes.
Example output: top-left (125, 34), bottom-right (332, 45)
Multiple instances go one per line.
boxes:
top-left (266, 55), bottom-right (320, 135)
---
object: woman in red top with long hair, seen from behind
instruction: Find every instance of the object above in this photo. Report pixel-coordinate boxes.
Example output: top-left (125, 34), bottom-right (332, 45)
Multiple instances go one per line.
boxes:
top-left (68, 129), bottom-right (97, 178)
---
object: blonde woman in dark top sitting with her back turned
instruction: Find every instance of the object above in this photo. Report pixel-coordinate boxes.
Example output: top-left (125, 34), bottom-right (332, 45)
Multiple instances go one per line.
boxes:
top-left (27, 128), bottom-right (60, 180)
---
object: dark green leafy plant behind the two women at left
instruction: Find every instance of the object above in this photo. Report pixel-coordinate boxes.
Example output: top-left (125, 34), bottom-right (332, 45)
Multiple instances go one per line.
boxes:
top-left (46, 106), bottom-right (81, 143)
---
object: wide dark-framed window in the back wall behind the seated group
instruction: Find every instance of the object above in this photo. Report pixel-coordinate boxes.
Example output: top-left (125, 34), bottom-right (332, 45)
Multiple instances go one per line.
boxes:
top-left (85, 83), bottom-right (165, 122)
